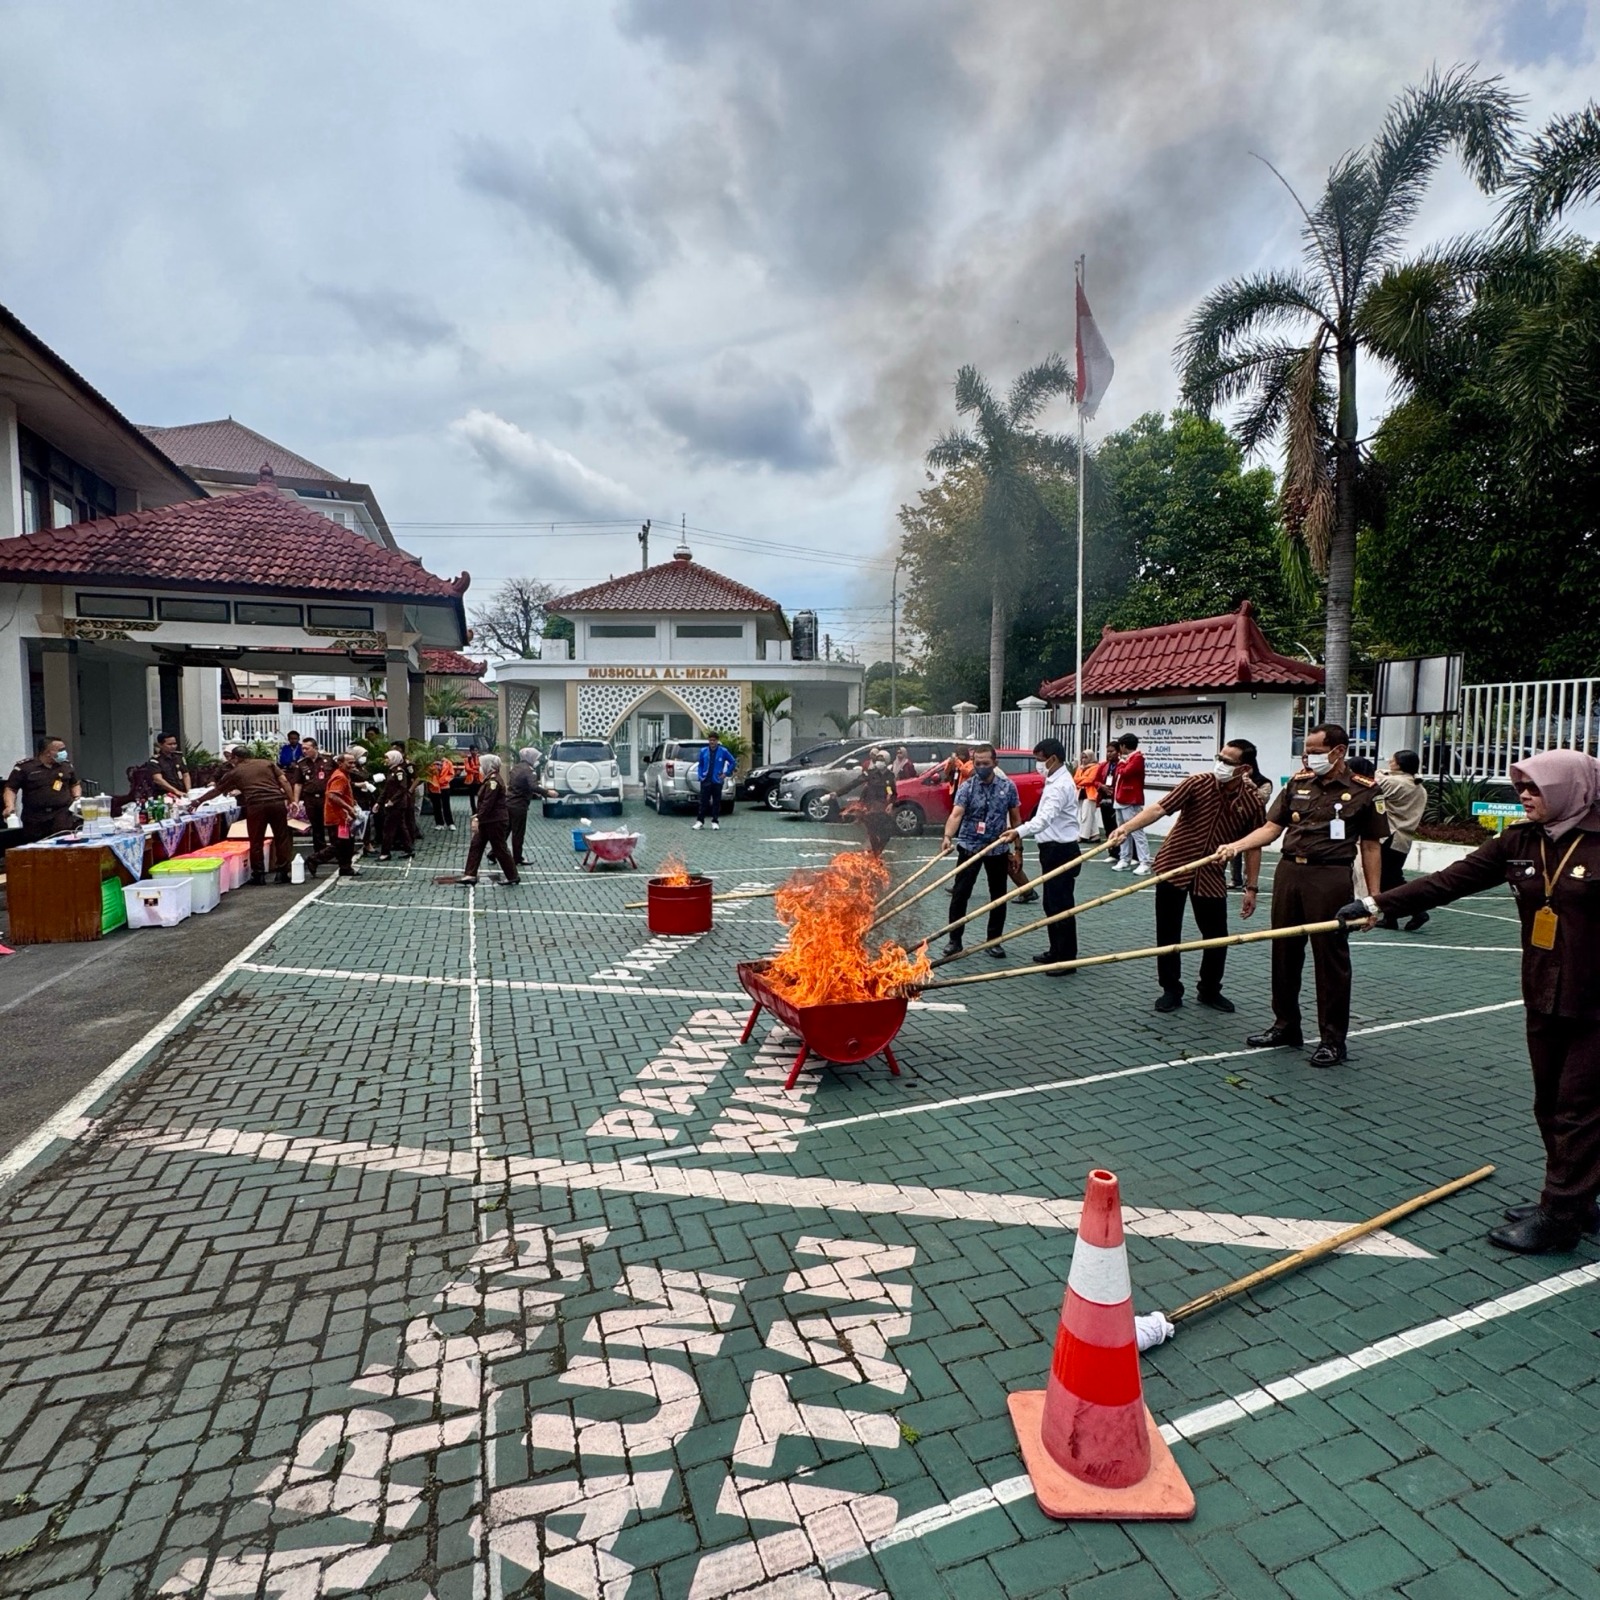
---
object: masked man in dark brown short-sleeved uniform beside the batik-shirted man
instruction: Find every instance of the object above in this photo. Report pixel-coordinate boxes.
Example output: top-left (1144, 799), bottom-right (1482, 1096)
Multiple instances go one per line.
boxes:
top-left (1219, 722), bottom-right (1389, 1067)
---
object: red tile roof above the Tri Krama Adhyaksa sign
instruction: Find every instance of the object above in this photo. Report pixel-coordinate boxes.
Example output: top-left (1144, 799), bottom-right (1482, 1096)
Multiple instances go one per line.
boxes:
top-left (1038, 600), bottom-right (1323, 701)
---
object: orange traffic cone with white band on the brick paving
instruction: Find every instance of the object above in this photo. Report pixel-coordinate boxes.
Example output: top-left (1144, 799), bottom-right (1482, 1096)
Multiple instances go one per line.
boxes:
top-left (1006, 1171), bottom-right (1195, 1522)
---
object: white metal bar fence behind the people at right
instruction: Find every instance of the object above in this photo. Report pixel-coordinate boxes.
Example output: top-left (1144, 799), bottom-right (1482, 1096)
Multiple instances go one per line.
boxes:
top-left (1294, 678), bottom-right (1600, 782)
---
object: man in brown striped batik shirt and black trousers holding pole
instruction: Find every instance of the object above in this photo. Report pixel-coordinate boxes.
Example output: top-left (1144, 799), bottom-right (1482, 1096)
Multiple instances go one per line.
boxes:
top-left (1110, 739), bottom-right (1267, 1011)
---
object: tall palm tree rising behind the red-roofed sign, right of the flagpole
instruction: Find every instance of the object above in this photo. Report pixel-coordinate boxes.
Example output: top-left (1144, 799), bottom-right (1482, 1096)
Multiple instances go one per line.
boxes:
top-left (1176, 67), bottom-right (1517, 715)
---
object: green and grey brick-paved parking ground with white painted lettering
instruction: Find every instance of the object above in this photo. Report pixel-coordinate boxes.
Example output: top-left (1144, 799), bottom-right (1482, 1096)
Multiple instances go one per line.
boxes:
top-left (0, 810), bottom-right (1600, 1600)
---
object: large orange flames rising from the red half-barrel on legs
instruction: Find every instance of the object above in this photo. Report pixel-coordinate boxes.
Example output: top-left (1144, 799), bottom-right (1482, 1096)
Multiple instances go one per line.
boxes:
top-left (766, 850), bottom-right (930, 1005)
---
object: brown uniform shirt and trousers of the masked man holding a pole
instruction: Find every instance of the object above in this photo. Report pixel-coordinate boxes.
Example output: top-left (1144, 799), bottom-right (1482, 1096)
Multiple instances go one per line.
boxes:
top-left (1267, 768), bottom-right (1389, 1050)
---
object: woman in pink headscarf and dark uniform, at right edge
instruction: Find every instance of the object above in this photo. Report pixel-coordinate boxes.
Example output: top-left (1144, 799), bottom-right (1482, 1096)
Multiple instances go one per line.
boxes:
top-left (1339, 750), bottom-right (1600, 1256)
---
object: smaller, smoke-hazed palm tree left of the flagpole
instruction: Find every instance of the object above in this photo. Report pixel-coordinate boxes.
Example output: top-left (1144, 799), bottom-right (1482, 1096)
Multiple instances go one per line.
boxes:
top-left (928, 363), bottom-right (1075, 728)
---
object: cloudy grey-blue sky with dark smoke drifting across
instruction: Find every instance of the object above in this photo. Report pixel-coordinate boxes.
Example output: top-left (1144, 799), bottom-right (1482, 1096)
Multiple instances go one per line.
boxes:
top-left (0, 0), bottom-right (1600, 658)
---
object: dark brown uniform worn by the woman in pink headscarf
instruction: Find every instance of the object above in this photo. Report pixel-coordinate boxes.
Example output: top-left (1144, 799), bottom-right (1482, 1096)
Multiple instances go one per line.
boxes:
top-left (1378, 822), bottom-right (1600, 1222)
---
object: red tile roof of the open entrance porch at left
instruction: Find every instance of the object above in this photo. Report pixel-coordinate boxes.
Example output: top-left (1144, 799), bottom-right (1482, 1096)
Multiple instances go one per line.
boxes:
top-left (0, 488), bottom-right (470, 606)
